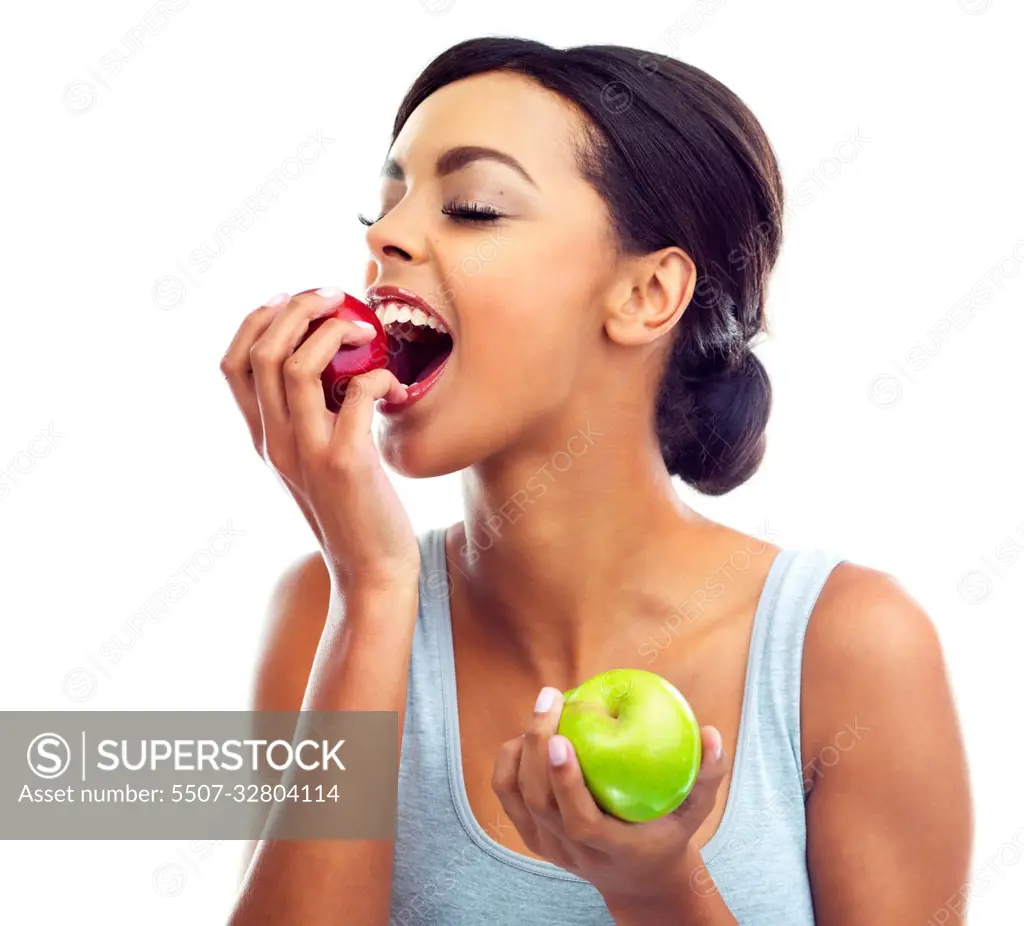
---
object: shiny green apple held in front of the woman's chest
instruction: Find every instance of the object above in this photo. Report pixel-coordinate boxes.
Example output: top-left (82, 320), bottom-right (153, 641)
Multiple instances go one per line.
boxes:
top-left (558, 669), bottom-right (701, 823)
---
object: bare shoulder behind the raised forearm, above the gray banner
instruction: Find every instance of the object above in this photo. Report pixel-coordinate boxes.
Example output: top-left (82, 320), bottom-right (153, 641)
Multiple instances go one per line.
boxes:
top-left (252, 551), bottom-right (331, 711)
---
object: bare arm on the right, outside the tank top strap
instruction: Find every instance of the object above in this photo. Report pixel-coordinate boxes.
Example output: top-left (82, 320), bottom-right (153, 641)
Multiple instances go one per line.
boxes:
top-left (803, 564), bottom-right (972, 926)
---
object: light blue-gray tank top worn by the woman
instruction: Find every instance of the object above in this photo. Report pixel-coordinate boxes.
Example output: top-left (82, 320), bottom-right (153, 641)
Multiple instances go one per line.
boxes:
top-left (390, 528), bottom-right (843, 926)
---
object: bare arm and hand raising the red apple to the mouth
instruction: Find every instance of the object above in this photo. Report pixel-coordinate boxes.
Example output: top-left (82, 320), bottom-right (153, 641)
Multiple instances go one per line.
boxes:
top-left (220, 290), bottom-right (421, 926)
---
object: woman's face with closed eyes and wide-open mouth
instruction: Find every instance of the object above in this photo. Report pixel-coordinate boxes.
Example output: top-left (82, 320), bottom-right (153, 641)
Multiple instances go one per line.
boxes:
top-left (367, 74), bottom-right (634, 476)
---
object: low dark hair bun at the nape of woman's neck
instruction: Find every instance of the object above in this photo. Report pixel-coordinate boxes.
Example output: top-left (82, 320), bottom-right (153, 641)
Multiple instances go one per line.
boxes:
top-left (658, 347), bottom-right (772, 495)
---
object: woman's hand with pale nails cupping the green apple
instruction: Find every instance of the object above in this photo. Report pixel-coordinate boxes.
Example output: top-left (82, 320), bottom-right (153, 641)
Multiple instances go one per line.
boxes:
top-left (492, 688), bottom-right (728, 902)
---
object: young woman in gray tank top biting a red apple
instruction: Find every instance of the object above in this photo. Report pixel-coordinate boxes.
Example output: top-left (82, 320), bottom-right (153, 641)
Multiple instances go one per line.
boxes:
top-left (222, 38), bottom-right (972, 926)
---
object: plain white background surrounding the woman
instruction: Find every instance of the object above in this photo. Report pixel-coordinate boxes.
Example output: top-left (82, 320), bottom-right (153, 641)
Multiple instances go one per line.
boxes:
top-left (0, 0), bottom-right (1024, 926)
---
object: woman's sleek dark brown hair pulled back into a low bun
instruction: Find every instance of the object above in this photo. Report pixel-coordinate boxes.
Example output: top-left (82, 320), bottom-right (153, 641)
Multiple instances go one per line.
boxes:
top-left (391, 37), bottom-right (783, 495)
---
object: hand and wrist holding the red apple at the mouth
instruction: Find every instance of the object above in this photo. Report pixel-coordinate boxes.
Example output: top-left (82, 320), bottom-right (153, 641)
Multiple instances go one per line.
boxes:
top-left (220, 291), bottom-right (420, 592)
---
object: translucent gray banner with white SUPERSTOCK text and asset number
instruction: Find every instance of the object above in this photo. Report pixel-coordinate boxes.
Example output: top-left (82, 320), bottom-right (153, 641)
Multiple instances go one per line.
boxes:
top-left (0, 711), bottom-right (398, 840)
